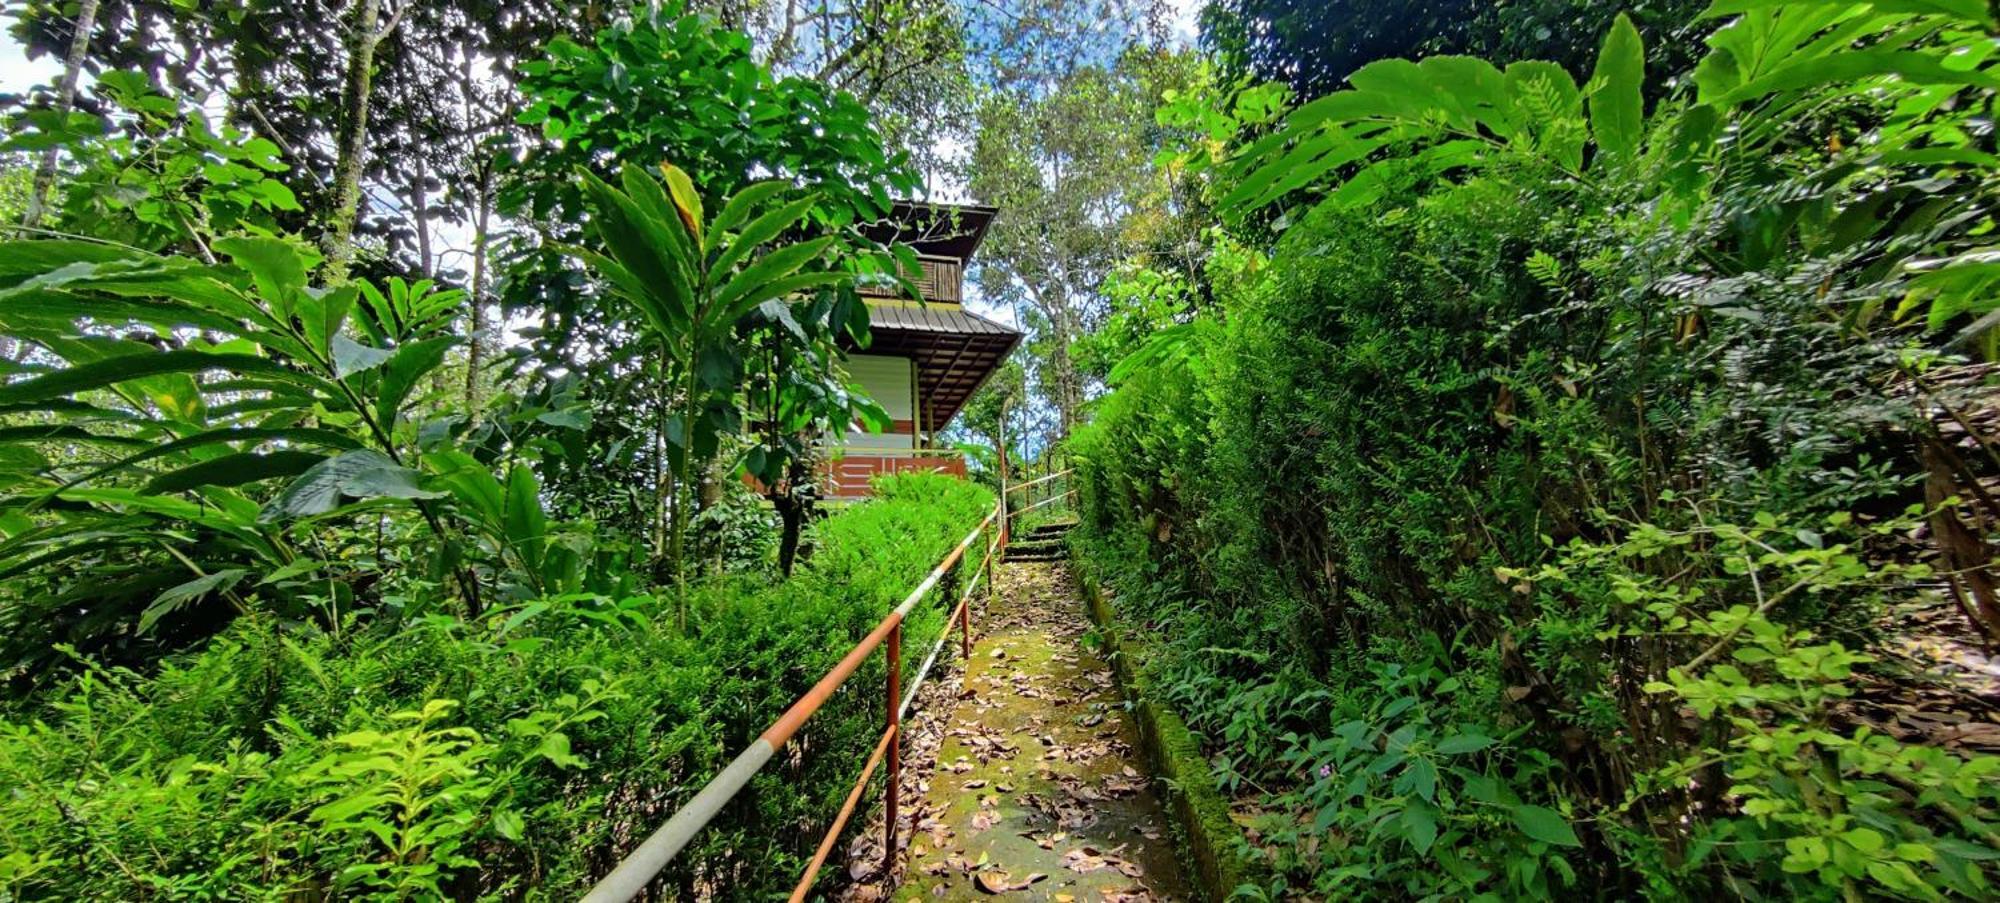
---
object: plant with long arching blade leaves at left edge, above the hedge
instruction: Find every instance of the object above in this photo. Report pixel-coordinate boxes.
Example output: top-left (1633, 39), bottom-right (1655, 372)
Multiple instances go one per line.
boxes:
top-left (0, 238), bottom-right (478, 671)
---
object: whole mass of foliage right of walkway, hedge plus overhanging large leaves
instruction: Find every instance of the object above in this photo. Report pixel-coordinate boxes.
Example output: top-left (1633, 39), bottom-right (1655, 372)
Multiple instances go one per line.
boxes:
top-left (1074, 2), bottom-right (2000, 899)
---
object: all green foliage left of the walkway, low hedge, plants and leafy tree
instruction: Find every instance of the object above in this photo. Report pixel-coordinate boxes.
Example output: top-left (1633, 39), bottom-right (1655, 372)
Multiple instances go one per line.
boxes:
top-left (0, 2), bottom-right (992, 899)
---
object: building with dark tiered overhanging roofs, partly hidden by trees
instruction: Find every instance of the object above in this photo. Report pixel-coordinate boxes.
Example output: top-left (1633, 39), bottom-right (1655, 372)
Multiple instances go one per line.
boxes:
top-left (826, 202), bottom-right (1020, 499)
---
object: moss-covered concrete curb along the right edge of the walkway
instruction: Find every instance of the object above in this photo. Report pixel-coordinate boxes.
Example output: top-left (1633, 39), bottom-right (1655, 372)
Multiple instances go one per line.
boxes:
top-left (1076, 559), bottom-right (1252, 901)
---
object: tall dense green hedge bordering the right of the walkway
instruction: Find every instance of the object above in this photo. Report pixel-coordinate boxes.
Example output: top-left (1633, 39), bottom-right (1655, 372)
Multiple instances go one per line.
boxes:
top-left (1072, 160), bottom-right (2000, 899)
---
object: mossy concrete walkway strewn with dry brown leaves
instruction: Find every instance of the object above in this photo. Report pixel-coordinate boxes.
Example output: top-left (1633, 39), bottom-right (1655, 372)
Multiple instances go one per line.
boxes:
top-left (864, 563), bottom-right (1190, 903)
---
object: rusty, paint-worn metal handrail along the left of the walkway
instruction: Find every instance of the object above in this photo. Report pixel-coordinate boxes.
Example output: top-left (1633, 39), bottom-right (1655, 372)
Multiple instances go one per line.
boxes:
top-left (584, 501), bottom-right (1006, 903)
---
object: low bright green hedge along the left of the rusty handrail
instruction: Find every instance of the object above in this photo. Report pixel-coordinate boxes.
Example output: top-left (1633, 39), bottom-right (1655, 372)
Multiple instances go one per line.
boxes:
top-left (0, 475), bottom-right (992, 899)
